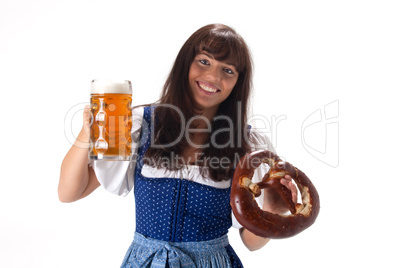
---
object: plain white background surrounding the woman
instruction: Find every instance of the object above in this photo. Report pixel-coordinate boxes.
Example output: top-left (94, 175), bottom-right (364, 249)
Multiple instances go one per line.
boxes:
top-left (0, 0), bottom-right (402, 268)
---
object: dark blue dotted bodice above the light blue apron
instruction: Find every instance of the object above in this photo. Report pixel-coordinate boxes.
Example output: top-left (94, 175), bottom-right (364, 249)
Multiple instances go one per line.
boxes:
top-left (134, 109), bottom-right (232, 242)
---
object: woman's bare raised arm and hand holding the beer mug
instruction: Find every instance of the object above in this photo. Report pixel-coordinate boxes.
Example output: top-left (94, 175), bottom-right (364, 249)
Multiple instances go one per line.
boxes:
top-left (58, 106), bottom-right (100, 202)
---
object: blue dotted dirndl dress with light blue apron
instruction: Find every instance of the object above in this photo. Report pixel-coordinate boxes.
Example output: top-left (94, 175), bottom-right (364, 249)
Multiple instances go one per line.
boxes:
top-left (121, 107), bottom-right (243, 268)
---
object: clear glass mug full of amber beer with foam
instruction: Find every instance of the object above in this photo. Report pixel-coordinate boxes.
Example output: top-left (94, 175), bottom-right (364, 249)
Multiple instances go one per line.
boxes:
top-left (89, 80), bottom-right (132, 160)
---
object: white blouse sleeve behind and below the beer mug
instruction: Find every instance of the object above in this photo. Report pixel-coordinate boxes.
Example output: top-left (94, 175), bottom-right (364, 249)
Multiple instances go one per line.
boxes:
top-left (88, 107), bottom-right (144, 196)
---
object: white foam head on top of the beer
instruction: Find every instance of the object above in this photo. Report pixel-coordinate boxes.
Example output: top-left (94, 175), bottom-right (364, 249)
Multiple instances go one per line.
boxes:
top-left (91, 79), bottom-right (132, 94)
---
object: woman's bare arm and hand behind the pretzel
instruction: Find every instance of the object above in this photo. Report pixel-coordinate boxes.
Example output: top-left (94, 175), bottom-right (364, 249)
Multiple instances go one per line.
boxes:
top-left (239, 175), bottom-right (297, 251)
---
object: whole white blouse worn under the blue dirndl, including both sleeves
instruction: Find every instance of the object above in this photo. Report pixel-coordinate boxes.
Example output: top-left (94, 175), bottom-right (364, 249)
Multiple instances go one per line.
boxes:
top-left (89, 107), bottom-right (275, 228)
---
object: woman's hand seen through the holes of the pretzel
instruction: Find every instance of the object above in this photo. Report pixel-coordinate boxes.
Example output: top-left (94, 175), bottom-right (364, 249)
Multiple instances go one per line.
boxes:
top-left (263, 175), bottom-right (297, 214)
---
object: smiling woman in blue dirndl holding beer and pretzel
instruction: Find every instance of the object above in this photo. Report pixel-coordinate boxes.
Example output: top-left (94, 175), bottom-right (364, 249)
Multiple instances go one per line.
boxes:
top-left (59, 24), bottom-right (296, 267)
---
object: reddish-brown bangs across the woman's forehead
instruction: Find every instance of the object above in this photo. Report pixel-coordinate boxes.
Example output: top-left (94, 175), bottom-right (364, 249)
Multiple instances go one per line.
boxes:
top-left (197, 29), bottom-right (248, 73)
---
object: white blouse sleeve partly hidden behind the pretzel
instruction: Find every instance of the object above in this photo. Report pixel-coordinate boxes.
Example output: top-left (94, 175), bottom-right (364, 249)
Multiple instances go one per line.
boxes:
top-left (232, 129), bottom-right (276, 229)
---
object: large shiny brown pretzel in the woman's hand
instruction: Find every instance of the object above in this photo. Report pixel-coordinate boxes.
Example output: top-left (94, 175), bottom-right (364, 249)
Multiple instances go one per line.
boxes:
top-left (230, 150), bottom-right (320, 239)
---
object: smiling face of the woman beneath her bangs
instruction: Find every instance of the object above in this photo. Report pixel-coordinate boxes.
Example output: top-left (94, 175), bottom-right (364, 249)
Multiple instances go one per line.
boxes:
top-left (189, 51), bottom-right (239, 117)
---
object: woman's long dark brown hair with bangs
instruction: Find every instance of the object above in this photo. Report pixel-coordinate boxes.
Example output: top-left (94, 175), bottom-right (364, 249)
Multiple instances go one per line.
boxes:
top-left (145, 24), bottom-right (252, 181)
